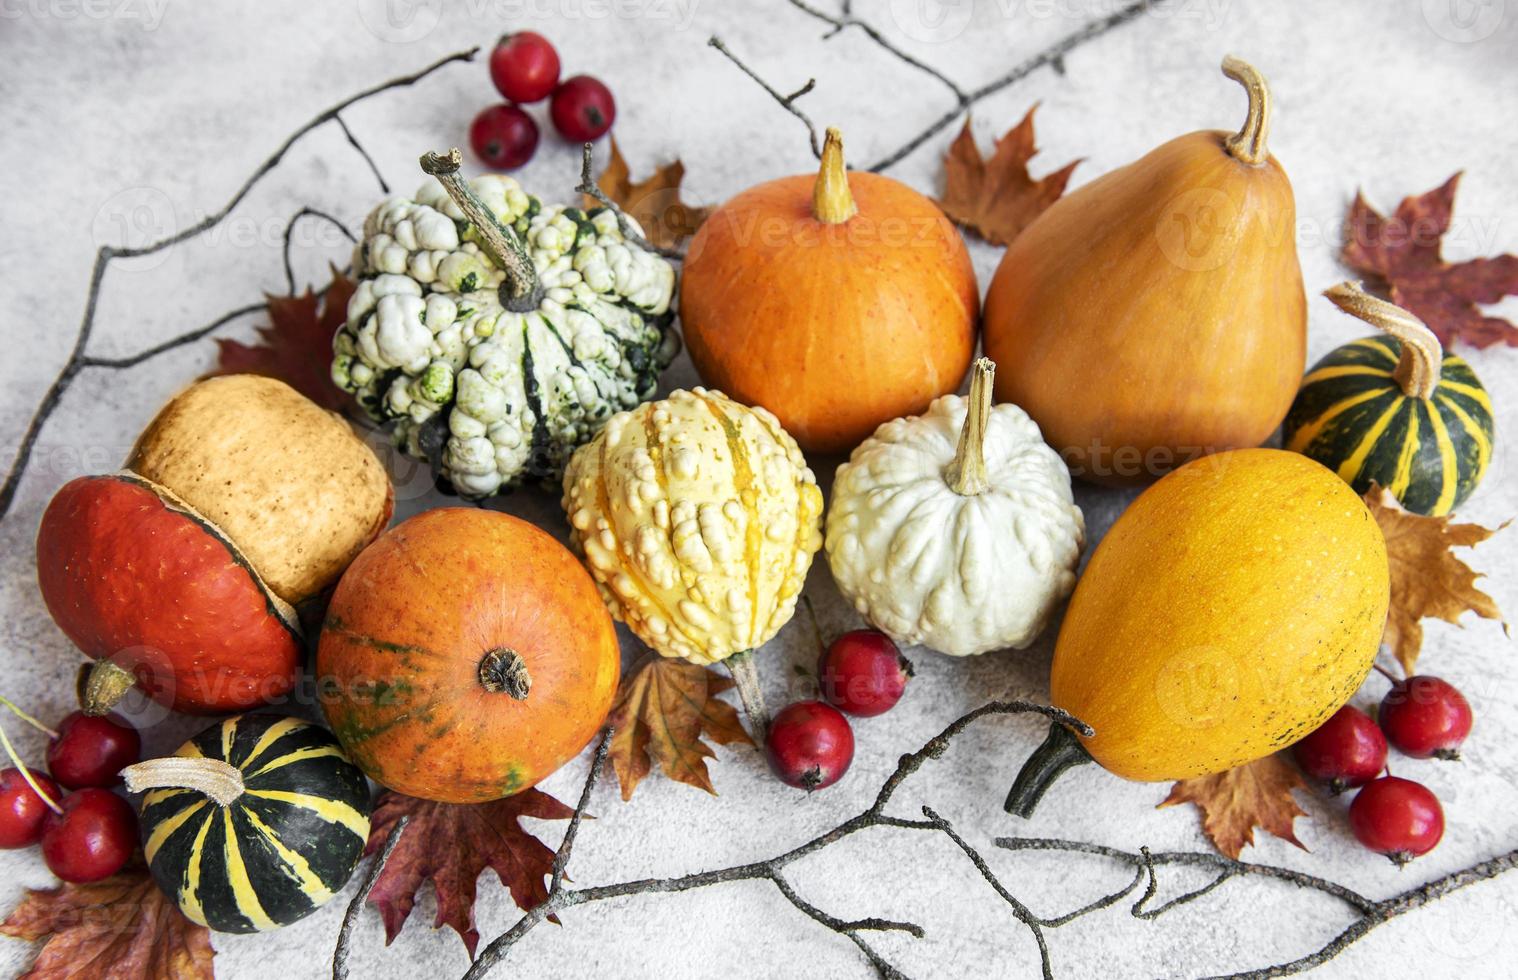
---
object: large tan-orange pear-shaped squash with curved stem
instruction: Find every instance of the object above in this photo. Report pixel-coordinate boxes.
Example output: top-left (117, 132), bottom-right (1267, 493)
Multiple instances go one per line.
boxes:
top-left (985, 58), bottom-right (1307, 485)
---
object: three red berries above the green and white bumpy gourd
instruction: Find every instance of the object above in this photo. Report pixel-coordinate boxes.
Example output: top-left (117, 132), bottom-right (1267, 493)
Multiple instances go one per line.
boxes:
top-left (469, 30), bottom-right (616, 170)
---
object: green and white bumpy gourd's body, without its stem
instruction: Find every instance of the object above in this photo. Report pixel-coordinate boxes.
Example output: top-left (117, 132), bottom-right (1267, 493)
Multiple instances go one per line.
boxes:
top-left (332, 174), bottom-right (679, 498)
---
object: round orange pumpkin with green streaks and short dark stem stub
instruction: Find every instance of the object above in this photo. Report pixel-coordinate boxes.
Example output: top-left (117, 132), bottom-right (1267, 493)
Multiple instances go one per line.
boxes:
top-left (316, 508), bottom-right (621, 803)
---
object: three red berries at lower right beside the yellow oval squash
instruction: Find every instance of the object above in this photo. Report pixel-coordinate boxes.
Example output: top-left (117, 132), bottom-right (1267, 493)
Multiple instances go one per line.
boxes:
top-left (1292, 675), bottom-right (1471, 865)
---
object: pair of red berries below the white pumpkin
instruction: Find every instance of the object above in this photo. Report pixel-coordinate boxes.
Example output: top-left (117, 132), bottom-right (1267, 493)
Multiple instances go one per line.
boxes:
top-left (765, 630), bottom-right (912, 790)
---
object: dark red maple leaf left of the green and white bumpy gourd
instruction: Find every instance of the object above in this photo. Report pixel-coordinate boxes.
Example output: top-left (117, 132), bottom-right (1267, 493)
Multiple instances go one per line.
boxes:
top-left (211, 269), bottom-right (354, 411)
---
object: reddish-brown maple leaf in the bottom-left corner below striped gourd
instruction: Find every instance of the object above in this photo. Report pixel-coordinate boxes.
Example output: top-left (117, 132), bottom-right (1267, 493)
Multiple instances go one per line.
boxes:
top-left (0, 865), bottom-right (216, 980)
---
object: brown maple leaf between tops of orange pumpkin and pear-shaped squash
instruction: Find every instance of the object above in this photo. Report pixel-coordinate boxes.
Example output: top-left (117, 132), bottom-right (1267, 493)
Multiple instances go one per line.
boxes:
top-left (938, 106), bottom-right (1081, 244)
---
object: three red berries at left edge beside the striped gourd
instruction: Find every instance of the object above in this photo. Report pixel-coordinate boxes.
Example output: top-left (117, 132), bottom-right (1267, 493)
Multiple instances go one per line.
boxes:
top-left (0, 702), bottom-right (143, 884)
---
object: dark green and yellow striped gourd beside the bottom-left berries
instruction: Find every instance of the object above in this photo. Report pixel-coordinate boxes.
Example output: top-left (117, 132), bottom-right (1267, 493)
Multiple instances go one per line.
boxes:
top-left (121, 715), bottom-right (369, 933)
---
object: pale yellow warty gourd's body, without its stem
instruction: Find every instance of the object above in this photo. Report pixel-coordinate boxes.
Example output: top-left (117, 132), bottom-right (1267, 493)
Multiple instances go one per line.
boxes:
top-left (563, 388), bottom-right (823, 664)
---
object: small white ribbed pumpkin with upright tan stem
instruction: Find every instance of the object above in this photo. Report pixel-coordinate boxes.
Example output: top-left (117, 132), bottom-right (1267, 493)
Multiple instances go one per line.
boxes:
top-left (826, 358), bottom-right (1085, 657)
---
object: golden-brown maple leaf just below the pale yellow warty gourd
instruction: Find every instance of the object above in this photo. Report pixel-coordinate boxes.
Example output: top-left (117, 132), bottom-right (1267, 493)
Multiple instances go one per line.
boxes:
top-left (607, 654), bottom-right (754, 799)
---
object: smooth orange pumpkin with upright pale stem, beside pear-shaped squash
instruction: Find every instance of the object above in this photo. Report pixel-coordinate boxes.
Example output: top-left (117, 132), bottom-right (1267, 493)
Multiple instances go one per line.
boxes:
top-left (680, 129), bottom-right (981, 454)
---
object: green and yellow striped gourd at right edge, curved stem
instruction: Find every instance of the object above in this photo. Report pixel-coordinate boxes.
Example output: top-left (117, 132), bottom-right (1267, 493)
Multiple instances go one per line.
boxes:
top-left (1283, 282), bottom-right (1494, 514)
